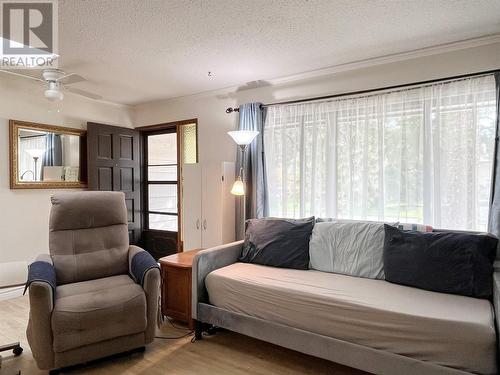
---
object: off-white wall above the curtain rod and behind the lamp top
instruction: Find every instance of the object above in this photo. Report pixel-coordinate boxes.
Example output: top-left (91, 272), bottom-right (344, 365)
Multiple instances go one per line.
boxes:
top-left (134, 41), bottom-right (500, 247)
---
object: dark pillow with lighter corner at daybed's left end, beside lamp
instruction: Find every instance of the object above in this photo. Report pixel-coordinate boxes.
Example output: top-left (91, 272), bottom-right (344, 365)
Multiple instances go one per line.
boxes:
top-left (239, 217), bottom-right (314, 270)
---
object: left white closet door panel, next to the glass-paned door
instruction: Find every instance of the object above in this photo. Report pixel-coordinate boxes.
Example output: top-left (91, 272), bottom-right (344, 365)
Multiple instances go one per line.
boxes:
top-left (182, 164), bottom-right (203, 251)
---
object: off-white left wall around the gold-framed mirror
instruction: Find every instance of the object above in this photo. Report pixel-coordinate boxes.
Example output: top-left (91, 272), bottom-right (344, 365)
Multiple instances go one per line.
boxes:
top-left (0, 77), bottom-right (132, 287)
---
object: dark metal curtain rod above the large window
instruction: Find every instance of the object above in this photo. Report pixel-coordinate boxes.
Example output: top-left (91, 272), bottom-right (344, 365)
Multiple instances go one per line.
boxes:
top-left (226, 69), bottom-right (500, 113)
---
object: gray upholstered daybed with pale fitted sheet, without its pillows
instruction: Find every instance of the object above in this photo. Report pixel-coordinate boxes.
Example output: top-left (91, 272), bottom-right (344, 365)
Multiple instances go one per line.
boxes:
top-left (192, 241), bottom-right (500, 375)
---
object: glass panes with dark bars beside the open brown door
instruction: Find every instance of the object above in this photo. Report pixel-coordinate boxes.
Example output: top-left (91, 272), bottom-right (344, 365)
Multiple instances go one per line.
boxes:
top-left (145, 128), bottom-right (178, 232)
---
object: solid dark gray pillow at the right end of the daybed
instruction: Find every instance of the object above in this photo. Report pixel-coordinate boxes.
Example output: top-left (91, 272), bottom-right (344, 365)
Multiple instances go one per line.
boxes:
top-left (384, 225), bottom-right (498, 298)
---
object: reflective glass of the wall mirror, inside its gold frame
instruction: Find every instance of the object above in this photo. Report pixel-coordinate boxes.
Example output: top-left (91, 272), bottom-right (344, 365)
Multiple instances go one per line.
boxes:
top-left (18, 128), bottom-right (80, 182)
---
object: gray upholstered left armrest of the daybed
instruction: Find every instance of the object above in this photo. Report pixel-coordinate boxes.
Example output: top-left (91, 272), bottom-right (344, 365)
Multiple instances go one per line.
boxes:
top-left (191, 241), bottom-right (243, 319)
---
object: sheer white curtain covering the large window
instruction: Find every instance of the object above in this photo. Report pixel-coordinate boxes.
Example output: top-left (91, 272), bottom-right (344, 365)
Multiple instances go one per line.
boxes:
top-left (264, 75), bottom-right (496, 230)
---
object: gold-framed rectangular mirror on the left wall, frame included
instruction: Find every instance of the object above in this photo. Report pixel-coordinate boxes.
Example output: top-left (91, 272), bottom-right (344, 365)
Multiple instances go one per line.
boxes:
top-left (9, 120), bottom-right (87, 189)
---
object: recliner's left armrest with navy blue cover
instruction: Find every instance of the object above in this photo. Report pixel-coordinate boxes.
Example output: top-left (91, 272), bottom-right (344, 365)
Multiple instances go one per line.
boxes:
top-left (26, 254), bottom-right (56, 369)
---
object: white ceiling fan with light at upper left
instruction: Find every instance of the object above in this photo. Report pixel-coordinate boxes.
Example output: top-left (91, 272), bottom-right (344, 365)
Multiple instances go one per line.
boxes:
top-left (0, 69), bottom-right (102, 101)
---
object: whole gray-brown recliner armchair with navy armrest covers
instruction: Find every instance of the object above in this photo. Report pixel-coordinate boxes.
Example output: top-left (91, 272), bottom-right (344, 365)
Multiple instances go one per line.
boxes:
top-left (26, 192), bottom-right (160, 370)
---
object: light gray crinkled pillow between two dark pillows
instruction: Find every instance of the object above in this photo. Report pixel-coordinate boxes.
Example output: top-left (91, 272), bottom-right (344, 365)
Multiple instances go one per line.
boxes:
top-left (309, 220), bottom-right (385, 279)
